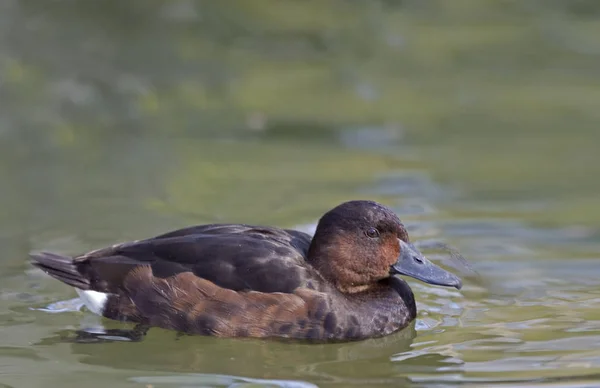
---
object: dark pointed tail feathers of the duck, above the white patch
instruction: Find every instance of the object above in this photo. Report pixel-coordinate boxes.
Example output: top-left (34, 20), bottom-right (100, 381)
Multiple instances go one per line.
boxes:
top-left (30, 252), bottom-right (90, 290)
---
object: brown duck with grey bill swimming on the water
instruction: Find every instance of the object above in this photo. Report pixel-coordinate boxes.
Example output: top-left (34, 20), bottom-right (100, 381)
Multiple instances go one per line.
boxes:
top-left (30, 200), bottom-right (462, 341)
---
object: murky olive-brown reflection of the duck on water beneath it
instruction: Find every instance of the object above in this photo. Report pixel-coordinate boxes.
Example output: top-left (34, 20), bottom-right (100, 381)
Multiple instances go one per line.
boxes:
top-left (40, 317), bottom-right (416, 386)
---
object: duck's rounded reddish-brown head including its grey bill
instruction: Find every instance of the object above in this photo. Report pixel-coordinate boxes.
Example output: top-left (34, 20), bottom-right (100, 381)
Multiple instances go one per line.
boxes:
top-left (308, 201), bottom-right (462, 293)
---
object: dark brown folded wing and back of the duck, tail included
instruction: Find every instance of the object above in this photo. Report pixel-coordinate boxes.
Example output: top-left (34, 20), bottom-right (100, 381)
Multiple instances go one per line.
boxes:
top-left (34, 224), bottom-right (310, 293)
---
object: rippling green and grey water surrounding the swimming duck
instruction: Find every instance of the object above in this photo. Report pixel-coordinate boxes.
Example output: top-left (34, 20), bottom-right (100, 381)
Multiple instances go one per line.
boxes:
top-left (0, 0), bottom-right (600, 387)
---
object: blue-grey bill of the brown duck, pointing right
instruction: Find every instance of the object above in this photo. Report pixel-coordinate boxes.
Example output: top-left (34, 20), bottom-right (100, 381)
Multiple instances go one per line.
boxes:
top-left (391, 239), bottom-right (462, 290)
